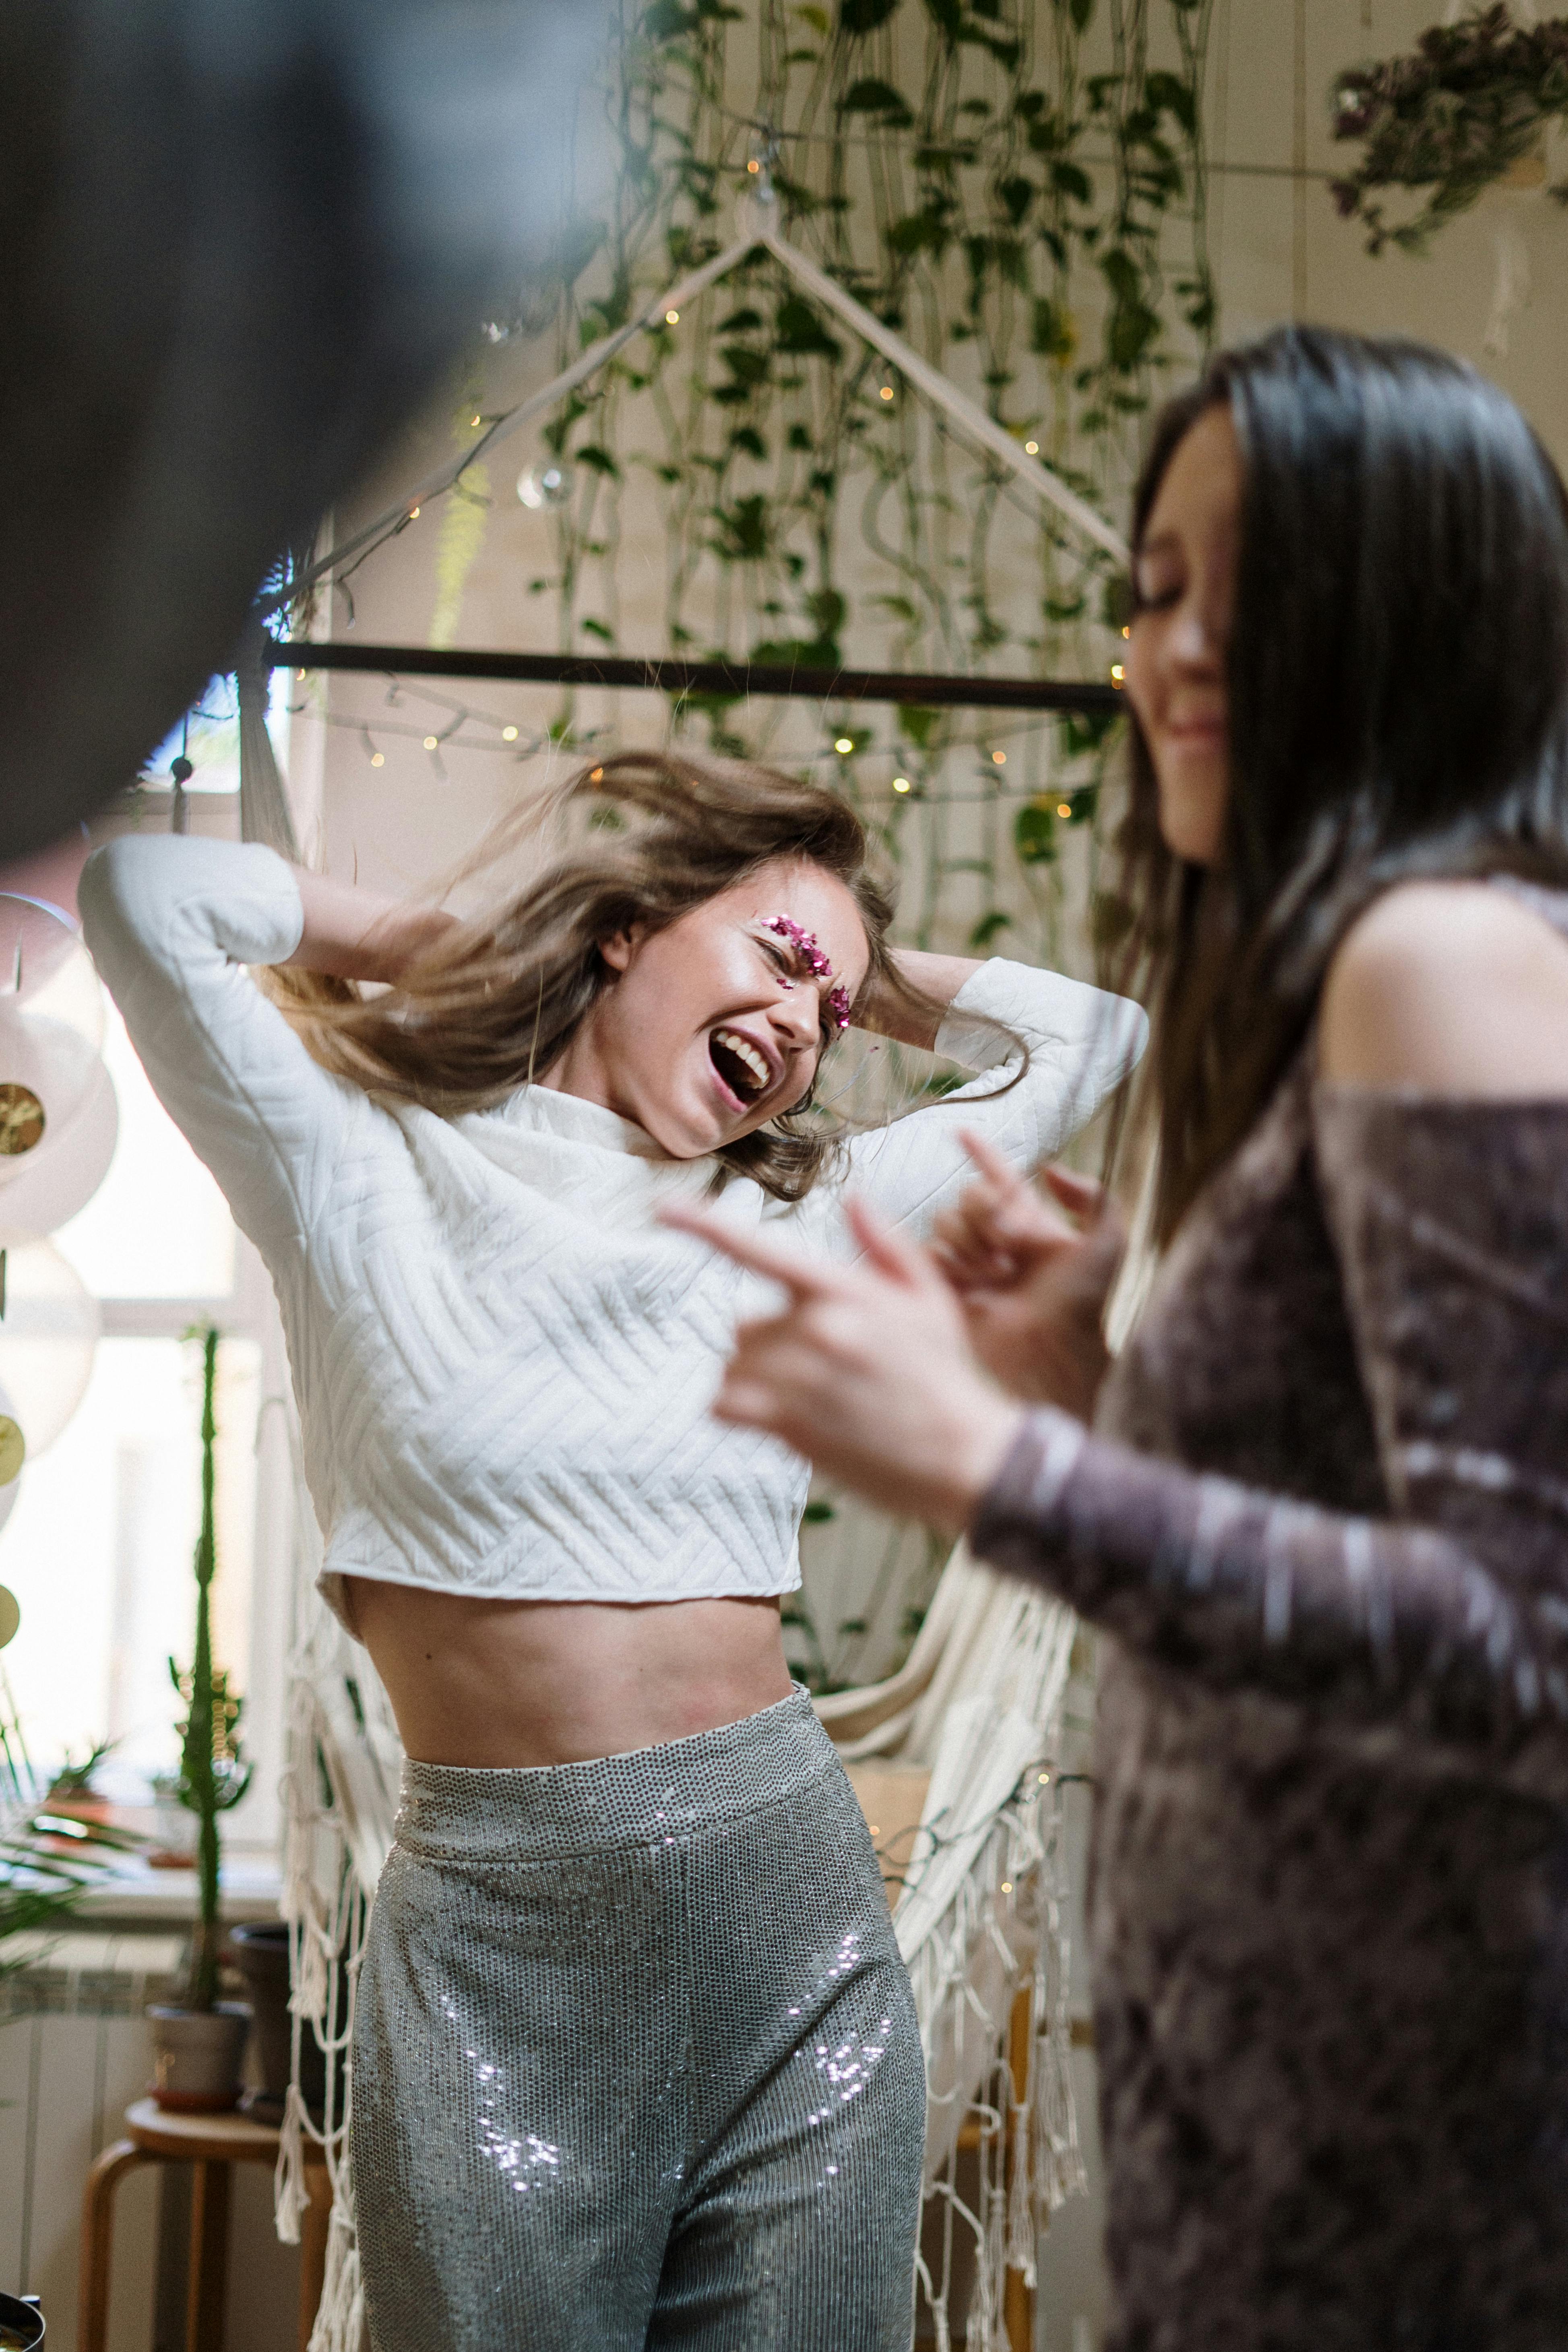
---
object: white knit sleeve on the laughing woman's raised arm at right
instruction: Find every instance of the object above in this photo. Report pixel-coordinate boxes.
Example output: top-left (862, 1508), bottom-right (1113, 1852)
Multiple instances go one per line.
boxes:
top-left (832, 957), bottom-right (1150, 1232)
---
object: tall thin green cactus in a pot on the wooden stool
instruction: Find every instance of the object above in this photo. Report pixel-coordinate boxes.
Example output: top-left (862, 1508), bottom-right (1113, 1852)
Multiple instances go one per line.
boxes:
top-left (148, 1331), bottom-right (249, 2112)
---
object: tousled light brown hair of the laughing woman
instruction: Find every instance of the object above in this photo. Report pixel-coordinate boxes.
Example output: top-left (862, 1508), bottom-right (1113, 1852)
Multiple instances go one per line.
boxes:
top-left (271, 750), bottom-right (1027, 1199)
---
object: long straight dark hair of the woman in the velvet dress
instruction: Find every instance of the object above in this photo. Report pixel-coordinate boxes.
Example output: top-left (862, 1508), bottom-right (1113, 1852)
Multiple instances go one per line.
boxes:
top-left (1109, 327), bottom-right (1568, 1242)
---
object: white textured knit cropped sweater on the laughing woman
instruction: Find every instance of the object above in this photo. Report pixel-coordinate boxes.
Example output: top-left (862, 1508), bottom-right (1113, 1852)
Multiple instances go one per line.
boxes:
top-left (80, 837), bottom-right (1145, 1614)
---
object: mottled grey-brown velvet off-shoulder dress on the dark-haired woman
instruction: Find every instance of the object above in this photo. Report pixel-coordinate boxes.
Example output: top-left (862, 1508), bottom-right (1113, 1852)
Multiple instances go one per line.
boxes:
top-left (971, 899), bottom-right (1568, 2352)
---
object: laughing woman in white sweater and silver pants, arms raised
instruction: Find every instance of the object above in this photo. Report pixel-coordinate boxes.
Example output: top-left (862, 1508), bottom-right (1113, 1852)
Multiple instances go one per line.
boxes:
top-left (80, 752), bottom-right (1142, 2352)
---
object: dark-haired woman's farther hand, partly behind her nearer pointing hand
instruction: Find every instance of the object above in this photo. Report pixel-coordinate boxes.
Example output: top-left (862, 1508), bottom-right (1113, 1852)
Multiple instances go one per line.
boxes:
top-left (931, 1129), bottom-right (1126, 1421)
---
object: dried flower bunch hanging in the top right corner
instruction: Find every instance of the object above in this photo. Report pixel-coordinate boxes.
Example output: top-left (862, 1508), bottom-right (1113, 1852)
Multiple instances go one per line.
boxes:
top-left (1333, 0), bottom-right (1568, 254)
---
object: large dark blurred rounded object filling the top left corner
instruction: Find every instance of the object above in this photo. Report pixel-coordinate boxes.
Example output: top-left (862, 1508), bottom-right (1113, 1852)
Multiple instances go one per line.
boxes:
top-left (0, 0), bottom-right (604, 856)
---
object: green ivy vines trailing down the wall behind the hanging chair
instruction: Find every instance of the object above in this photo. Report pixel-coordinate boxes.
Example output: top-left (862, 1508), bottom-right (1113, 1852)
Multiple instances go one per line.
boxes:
top-left (472, 0), bottom-right (1215, 973)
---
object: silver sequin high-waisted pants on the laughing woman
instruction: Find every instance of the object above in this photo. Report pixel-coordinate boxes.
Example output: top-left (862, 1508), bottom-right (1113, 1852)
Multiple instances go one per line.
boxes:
top-left (353, 1691), bottom-right (926, 2352)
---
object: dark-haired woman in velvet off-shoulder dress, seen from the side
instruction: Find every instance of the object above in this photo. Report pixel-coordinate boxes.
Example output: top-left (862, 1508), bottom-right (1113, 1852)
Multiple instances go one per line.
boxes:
top-left (684, 329), bottom-right (1568, 2352)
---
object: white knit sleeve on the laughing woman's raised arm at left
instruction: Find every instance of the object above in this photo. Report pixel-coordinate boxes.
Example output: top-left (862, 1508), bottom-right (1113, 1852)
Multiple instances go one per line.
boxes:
top-left (78, 835), bottom-right (353, 1254)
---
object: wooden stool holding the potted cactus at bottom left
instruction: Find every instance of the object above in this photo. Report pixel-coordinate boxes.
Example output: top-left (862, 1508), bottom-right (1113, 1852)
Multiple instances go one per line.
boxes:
top-left (75, 2098), bottom-right (331, 2352)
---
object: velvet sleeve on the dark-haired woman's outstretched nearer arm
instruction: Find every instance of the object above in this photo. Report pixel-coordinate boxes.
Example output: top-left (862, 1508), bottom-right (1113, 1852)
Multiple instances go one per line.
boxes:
top-left (971, 1091), bottom-right (1568, 1799)
